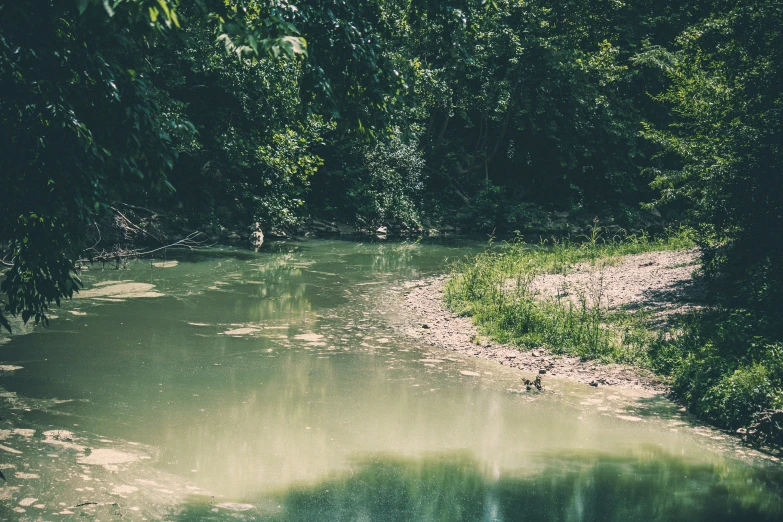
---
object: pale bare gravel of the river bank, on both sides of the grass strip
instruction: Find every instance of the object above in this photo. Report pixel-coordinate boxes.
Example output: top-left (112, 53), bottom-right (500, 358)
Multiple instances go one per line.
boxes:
top-left (401, 251), bottom-right (696, 393)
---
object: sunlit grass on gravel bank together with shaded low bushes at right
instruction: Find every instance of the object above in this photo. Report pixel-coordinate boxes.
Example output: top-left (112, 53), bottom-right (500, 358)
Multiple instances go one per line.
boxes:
top-left (444, 227), bottom-right (783, 434)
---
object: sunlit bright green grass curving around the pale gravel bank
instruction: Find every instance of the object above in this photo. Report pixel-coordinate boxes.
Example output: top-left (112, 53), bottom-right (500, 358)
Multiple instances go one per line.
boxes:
top-left (444, 224), bottom-right (693, 366)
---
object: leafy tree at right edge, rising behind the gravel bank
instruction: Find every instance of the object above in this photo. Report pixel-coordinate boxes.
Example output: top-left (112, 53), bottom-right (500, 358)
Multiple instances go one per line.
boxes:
top-left (637, 0), bottom-right (783, 310)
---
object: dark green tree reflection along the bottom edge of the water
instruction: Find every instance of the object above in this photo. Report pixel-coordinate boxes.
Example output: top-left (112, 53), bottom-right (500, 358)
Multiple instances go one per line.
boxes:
top-left (176, 449), bottom-right (783, 522)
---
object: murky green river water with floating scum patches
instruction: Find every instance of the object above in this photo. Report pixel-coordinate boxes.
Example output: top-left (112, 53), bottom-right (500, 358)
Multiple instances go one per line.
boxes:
top-left (0, 241), bottom-right (783, 521)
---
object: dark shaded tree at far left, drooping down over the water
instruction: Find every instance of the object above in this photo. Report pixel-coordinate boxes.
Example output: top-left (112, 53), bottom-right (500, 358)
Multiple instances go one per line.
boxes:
top-left (0, 2), bottom-right (185, 329)
